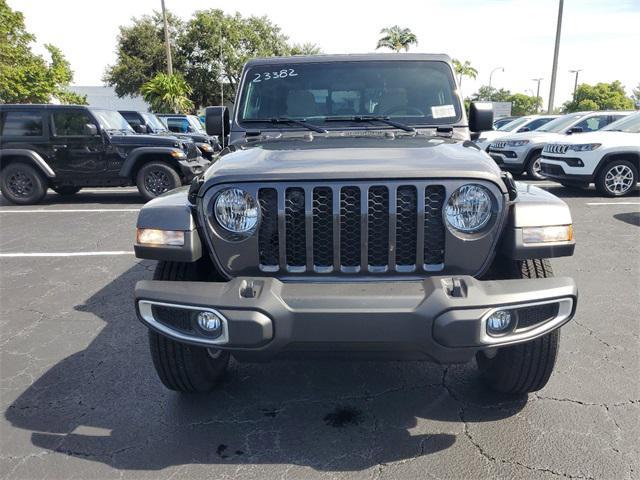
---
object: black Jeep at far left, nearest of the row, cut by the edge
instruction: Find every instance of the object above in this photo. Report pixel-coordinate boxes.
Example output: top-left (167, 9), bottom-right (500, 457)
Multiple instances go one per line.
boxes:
top-left (0, 105), bottom-right (210, 205)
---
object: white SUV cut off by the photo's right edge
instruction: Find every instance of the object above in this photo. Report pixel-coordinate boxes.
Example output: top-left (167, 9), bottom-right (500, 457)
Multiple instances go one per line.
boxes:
top-left (540, 113), bottom-right (640, 197)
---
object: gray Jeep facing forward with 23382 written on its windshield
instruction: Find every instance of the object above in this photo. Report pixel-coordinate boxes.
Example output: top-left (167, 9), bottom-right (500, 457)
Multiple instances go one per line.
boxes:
top-left (135, 54), bottom-right (577, 394)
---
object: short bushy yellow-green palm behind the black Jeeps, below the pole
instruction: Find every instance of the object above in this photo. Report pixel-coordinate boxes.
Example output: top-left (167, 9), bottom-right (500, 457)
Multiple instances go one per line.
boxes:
top-left (140, 73), bottom-right (193, 113)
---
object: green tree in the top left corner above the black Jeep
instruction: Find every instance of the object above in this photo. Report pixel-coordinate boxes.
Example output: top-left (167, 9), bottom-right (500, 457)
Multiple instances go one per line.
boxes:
top-left (0, 0), bottom-right (86, 103)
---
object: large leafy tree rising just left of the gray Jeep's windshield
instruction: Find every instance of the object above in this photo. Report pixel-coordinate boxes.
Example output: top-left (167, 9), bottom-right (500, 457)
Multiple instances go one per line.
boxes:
top-left (178, 9), bottom-right (292, 106)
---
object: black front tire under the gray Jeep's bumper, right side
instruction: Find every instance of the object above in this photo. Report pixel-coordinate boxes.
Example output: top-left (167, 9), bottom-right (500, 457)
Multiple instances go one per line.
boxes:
top-left (476, 259), bottom-right (560, 395)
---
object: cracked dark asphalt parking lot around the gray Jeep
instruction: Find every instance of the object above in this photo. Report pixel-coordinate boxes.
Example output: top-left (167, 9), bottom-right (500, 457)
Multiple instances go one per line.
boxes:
top-left (0, 182), bottom-right (640, 479)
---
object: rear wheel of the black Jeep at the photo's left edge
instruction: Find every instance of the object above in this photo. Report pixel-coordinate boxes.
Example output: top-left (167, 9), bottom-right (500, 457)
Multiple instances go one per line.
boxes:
top-left (0, 162), bottom-right (47, 205)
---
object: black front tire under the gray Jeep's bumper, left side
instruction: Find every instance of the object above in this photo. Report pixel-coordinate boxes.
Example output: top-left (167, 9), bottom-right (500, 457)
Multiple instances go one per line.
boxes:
top-left (149, 262), bottom-right (229, 393)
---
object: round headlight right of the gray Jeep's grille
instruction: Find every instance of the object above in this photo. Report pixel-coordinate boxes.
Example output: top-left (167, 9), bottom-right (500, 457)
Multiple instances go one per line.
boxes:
top-left (444, 184), bottom-right (491, 233)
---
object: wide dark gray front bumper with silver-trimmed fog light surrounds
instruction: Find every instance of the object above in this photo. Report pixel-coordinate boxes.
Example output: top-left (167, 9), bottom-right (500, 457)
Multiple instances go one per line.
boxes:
top-left (135, 276), bottom-right (577, 363)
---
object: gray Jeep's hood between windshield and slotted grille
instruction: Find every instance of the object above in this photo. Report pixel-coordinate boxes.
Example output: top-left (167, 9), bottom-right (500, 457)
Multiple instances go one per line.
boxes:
top-left (205, 136), bottom-right (503, 188)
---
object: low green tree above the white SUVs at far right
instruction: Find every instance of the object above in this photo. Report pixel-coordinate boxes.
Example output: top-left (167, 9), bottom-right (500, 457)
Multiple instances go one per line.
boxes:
top-left (562, 80), bottom-right (634, 113)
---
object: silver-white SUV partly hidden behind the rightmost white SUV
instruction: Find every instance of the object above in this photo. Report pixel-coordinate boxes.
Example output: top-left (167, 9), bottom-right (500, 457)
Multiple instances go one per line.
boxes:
top-left (487, 111), bottom-right (631, 180)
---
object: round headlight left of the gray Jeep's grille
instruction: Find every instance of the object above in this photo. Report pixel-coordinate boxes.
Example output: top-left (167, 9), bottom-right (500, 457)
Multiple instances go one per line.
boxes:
top-left (214, 188), bottom-right (258, 233)
